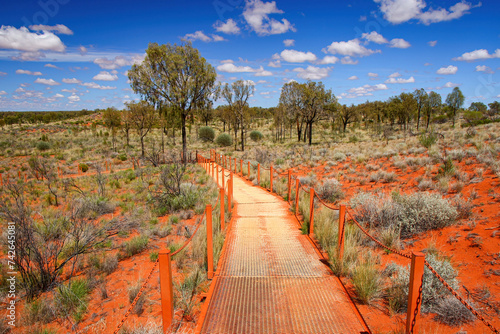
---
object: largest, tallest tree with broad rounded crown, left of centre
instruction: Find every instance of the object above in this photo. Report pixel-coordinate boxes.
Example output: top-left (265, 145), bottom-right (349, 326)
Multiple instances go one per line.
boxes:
top-left (128, 42), bottom-right (217, 162)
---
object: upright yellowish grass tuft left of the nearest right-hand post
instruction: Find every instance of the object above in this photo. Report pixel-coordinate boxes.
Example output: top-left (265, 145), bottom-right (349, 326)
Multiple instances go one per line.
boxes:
top-left (352, 252), bottom-right (382, 304)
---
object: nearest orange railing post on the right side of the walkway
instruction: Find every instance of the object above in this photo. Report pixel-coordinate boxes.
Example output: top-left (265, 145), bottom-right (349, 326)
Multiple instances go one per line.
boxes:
top-left (406, 252), bottom-right (425, 334)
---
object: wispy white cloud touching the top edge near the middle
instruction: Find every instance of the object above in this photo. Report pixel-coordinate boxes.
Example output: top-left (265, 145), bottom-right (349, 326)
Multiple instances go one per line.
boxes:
top-left (243, 0), bottom-right (296, 36)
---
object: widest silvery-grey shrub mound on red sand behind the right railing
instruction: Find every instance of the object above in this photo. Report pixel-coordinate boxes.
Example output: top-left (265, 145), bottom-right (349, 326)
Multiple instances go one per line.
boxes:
top-left (351, 193), bottom-right (458, 238)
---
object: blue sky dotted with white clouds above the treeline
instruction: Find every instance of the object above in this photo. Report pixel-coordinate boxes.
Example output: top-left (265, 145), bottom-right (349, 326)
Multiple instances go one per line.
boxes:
top-left (0, 0), bottom-right (500, 110)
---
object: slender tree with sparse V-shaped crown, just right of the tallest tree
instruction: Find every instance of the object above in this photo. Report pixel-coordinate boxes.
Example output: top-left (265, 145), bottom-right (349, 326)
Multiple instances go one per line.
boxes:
top-left (222, 80), bottom-right (255, 151)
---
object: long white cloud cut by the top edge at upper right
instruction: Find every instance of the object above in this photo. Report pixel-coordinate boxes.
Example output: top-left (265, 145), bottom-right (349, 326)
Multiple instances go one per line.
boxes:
top-left (374, 0), bottom-right (481, 25)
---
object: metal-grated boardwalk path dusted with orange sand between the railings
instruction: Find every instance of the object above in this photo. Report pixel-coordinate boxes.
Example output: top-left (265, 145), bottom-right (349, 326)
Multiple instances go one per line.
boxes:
top-left (197, 171), bottom-right (368, 334)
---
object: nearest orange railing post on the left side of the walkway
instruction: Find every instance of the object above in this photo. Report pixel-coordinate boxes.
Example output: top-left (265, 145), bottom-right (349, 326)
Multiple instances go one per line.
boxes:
top-left (162, 249), bottom-right (174, 333)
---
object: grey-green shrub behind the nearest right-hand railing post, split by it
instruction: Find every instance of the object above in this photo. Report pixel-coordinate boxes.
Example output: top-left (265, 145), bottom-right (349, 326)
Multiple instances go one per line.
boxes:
top-left (387, 254), bottom-right (458, 312)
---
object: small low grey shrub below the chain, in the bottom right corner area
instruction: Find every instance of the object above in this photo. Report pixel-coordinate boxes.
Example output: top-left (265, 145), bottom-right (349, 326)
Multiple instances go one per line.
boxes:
top-left (434, 296), bottom-right (476, 326)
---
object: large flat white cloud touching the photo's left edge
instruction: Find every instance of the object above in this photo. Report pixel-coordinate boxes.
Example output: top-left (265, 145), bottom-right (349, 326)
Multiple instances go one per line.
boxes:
top-left (0, 26), bottom-right (66, 52)
